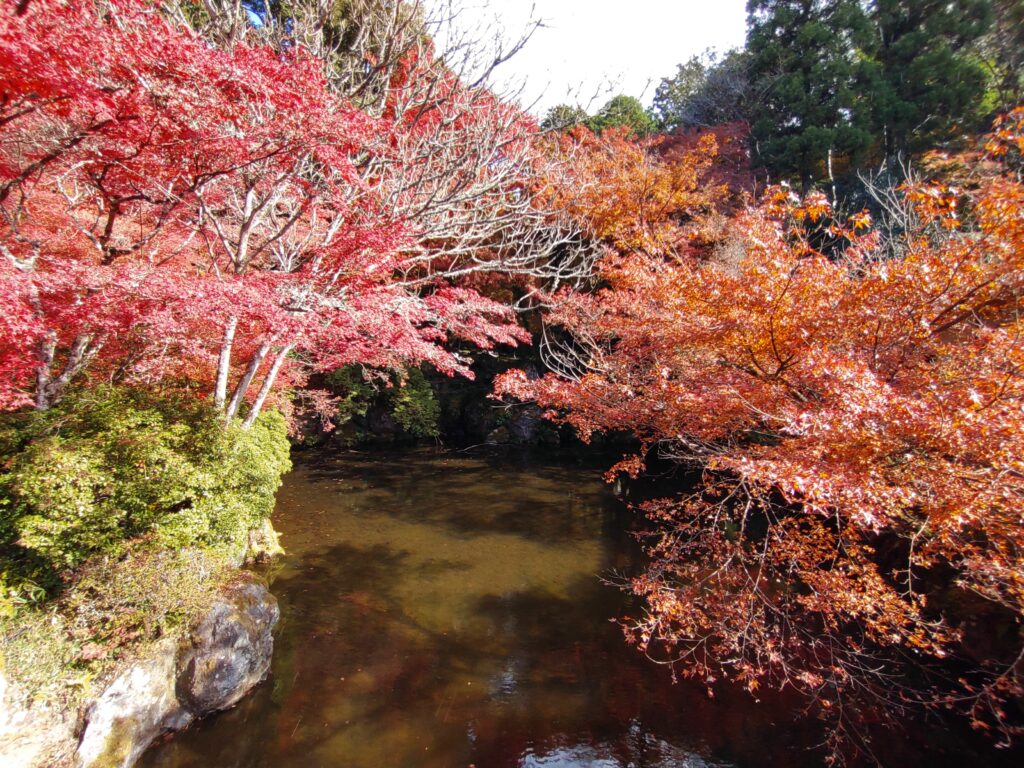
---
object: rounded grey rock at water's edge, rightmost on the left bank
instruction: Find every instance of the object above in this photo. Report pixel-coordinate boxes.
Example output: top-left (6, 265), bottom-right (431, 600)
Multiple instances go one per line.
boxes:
top-left (176, 577), bottom-right (280, 716)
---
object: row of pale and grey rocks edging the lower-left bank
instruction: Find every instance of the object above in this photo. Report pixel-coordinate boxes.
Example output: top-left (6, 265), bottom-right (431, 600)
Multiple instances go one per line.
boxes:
top-left (0, 572), bottom-right (279, 768)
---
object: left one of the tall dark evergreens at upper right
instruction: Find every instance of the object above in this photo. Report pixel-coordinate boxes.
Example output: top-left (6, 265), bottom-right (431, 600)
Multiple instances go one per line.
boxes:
top-left (746, 0), bottom-right (871, 190)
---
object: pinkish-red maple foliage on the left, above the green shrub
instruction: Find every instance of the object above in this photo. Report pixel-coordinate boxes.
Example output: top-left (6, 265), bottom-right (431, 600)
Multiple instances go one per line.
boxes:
top-left (0, 0), bottom-right (524, 421)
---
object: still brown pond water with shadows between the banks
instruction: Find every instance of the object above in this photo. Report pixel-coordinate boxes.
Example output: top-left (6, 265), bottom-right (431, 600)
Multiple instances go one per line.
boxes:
top-left (140, 450), bottom-right (1015, 768)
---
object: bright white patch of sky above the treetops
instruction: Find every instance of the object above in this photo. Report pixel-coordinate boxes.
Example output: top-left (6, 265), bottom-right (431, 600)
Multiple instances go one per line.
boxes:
top-left (426, 0), bottom-right (745, 116)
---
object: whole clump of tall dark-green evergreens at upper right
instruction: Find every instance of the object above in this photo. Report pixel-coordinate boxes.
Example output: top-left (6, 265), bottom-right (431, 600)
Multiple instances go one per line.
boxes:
top-left (749, 0), bottom-right (995, 188)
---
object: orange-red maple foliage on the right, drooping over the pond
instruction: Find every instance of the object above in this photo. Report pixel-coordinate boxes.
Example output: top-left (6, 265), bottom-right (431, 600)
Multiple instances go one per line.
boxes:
top-left (499, 121), bottom-right (1024, 755)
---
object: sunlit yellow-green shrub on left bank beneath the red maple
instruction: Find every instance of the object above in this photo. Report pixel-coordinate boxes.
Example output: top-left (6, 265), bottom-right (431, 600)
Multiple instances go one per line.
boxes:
top-left (0, 388), bottom-right (290, 600)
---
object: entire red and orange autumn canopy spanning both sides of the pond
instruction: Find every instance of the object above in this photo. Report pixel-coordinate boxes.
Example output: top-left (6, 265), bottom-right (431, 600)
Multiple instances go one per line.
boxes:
top-left (0, 0), bottom-right (1024, 756)
